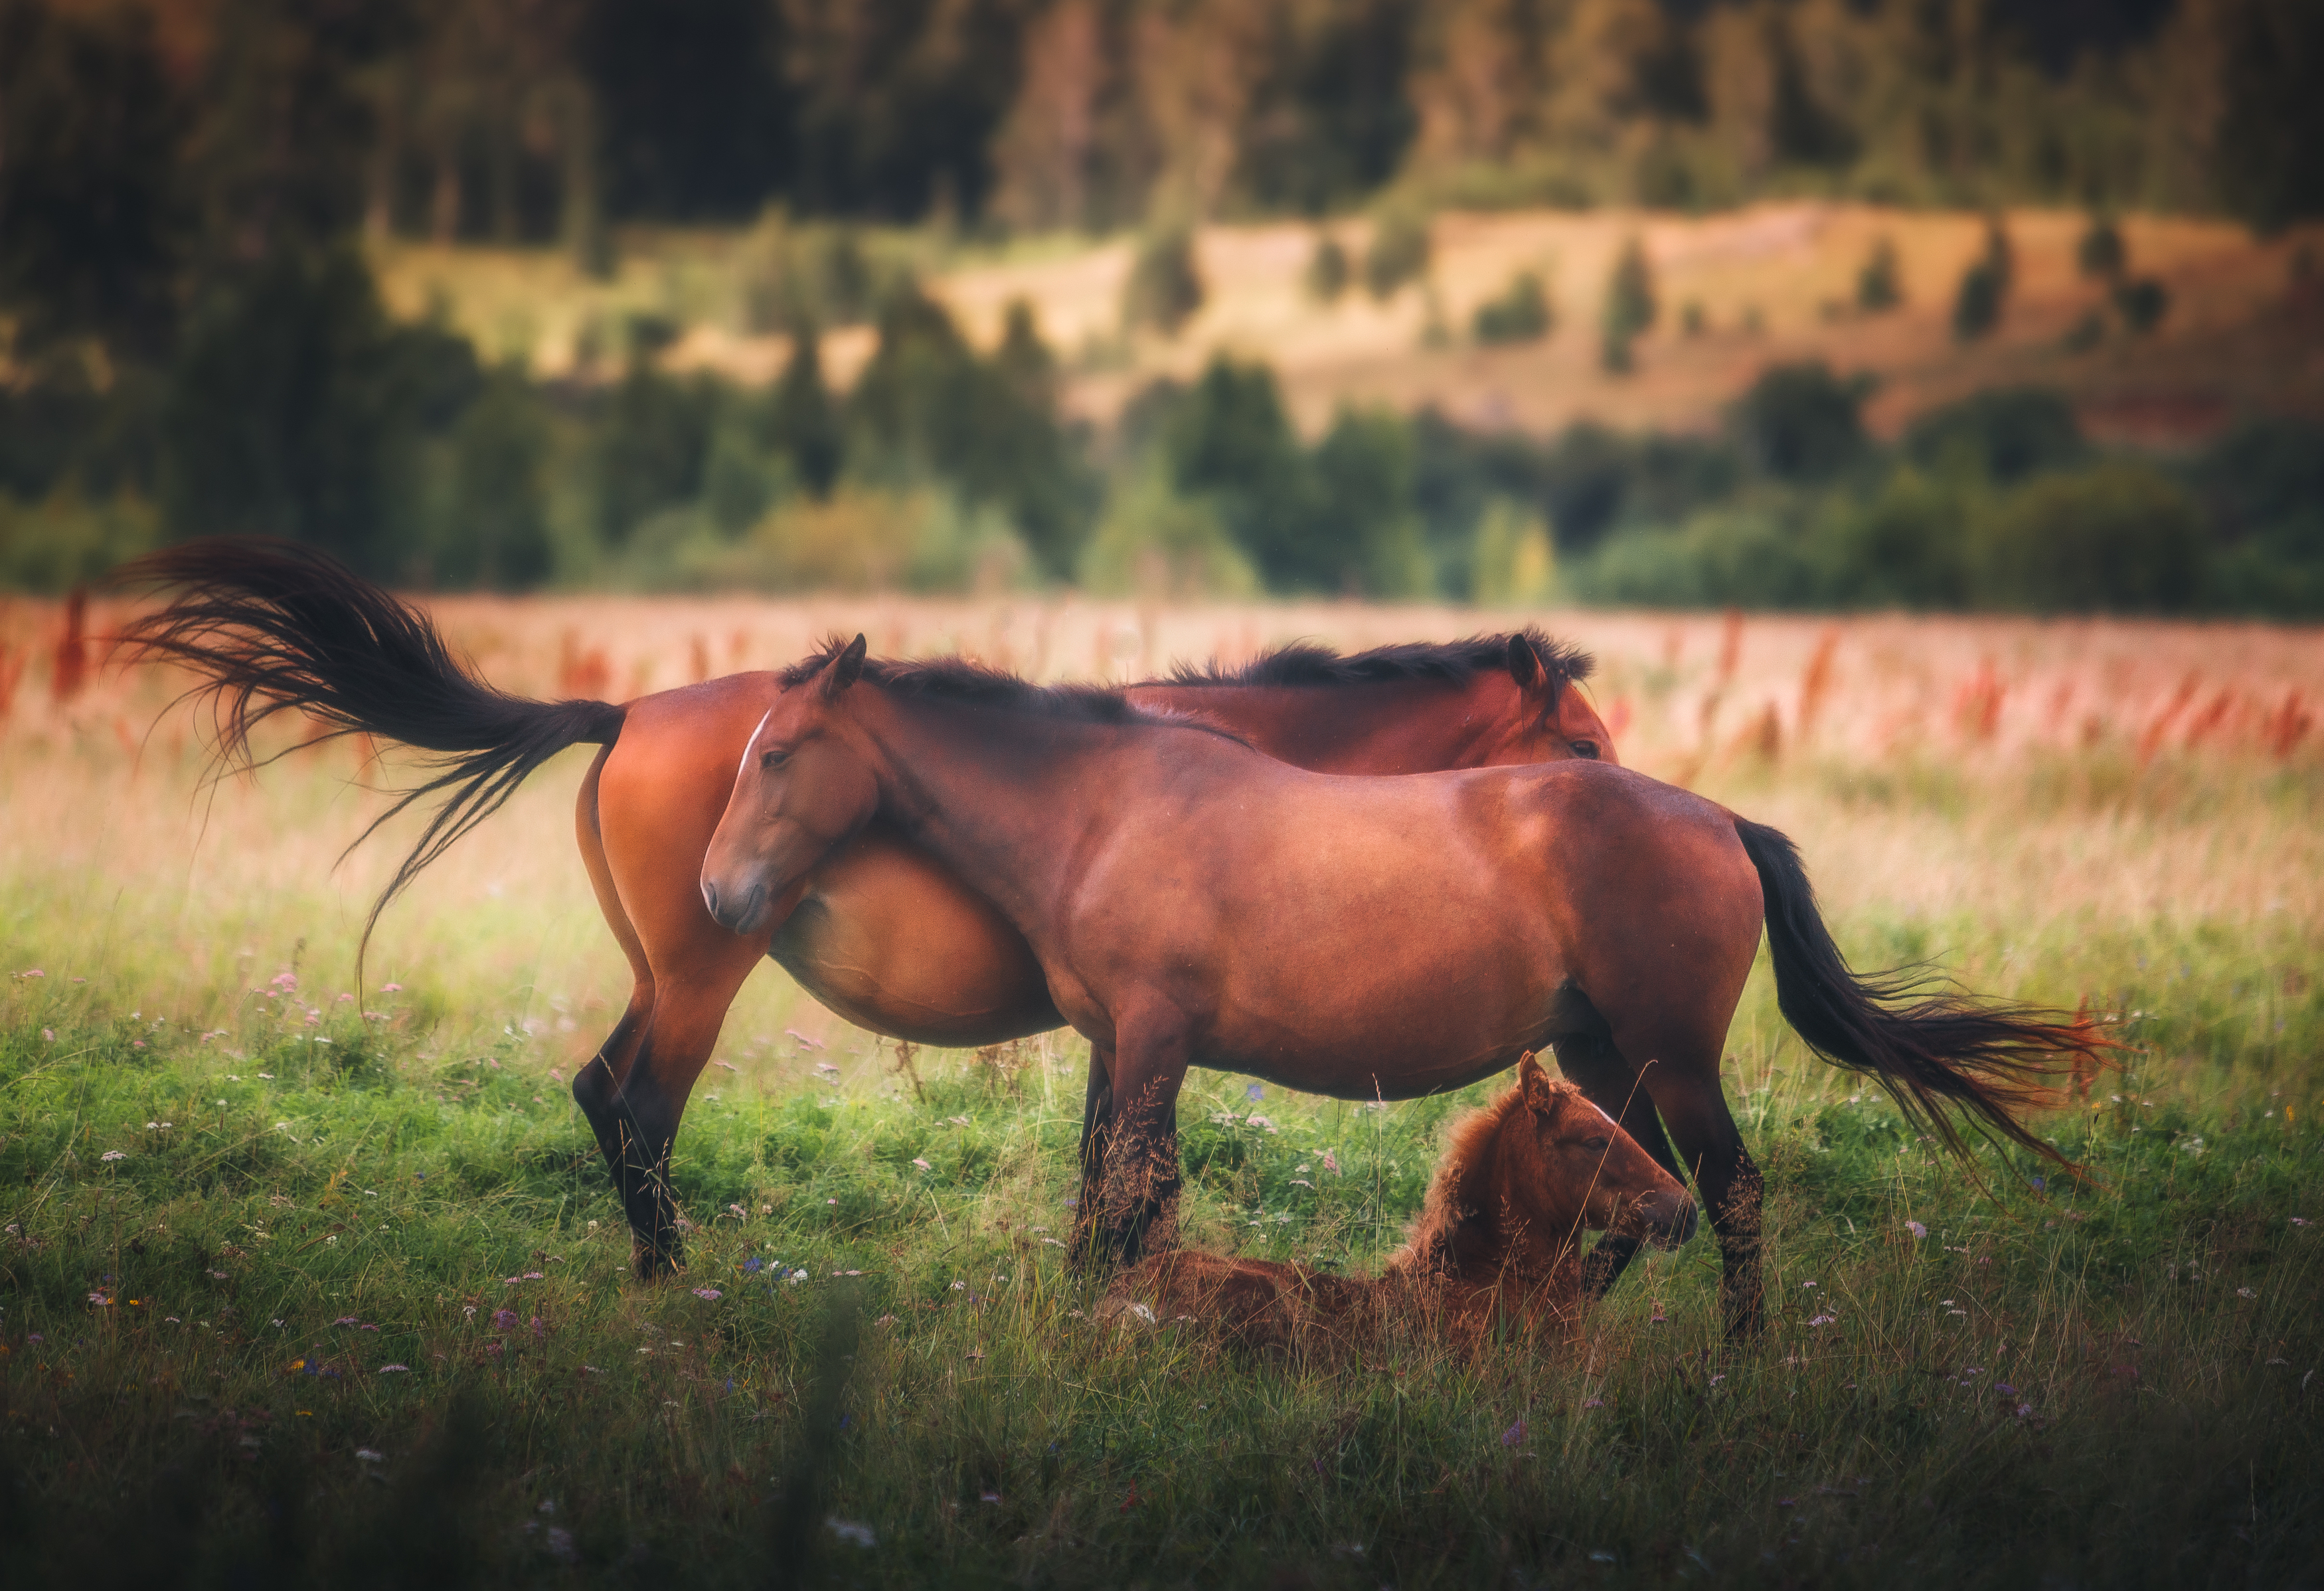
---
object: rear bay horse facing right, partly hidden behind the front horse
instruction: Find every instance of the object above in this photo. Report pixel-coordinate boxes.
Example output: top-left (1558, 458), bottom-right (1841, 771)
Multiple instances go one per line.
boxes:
top-left (116, 539), bottom-right (1616, 1275)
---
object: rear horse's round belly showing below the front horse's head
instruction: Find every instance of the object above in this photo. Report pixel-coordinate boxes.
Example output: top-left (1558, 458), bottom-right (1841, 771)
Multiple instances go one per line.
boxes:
top-left (770, 829), bottom-right (1062, 1048)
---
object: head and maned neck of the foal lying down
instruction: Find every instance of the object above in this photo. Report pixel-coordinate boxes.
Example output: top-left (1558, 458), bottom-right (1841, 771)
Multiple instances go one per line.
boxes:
top-left (1422, 1054), bottom-right (1695, 1247)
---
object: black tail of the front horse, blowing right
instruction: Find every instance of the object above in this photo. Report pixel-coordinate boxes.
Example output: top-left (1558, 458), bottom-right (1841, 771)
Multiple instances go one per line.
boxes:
top-left (1734, 817), bottom-right (2119, 1166)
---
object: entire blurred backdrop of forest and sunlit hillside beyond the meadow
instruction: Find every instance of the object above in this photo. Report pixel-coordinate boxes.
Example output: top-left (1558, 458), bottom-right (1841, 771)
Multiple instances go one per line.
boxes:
top-left (0, 0), bottom-right (2324, 618)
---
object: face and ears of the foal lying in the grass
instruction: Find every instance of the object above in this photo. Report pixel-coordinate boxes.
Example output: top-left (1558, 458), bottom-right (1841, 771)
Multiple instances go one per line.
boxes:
top-left (1495, 1054), bottom-right (1695, 1247)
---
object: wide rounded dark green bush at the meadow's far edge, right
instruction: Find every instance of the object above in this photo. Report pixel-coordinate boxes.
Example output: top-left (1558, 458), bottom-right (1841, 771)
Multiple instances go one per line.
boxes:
top-left (1980, 462), bottom-right (2208, 613)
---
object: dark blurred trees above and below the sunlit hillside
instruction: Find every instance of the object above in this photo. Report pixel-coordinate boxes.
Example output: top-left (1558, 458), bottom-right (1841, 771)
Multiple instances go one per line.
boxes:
top-left (13, 0), bottom-right (2324, 613)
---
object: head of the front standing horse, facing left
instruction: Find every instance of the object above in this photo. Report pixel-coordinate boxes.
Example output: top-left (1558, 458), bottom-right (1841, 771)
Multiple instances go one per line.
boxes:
top-left (702, 636), bottom-right (878, 934)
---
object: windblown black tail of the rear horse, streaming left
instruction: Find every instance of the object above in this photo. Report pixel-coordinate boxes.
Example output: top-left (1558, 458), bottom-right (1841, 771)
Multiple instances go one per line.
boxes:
top-left (112, 537), bottom-right (623, 955)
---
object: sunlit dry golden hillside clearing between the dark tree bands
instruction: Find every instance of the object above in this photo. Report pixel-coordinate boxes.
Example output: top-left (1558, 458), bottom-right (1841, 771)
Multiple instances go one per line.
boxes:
top-left (379, 202), bottom-right (2324, 446)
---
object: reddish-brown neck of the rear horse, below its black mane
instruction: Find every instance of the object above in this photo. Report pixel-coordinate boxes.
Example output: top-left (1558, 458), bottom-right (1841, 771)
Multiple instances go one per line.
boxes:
top-left (1129, 673), bottom-right (1515, 774)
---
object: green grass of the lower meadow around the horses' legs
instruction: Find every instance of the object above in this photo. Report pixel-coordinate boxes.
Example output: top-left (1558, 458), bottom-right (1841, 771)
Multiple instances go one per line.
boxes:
top-left (0, 934), bottom-right (2324, 1586)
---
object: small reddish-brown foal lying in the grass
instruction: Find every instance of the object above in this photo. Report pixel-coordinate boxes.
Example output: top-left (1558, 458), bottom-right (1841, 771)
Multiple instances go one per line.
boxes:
top-left (1100, 1052), bottom-right (1695, 1354)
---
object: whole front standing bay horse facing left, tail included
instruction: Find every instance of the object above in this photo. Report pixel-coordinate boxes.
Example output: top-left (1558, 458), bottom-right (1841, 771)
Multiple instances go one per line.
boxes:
top-left (702, 636), bottom-right (2108, 1333)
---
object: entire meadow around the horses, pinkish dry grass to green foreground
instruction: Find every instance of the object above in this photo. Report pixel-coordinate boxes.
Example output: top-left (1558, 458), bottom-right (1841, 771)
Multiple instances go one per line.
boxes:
top-left (0, 599), bottom-right (2324, 1589)
